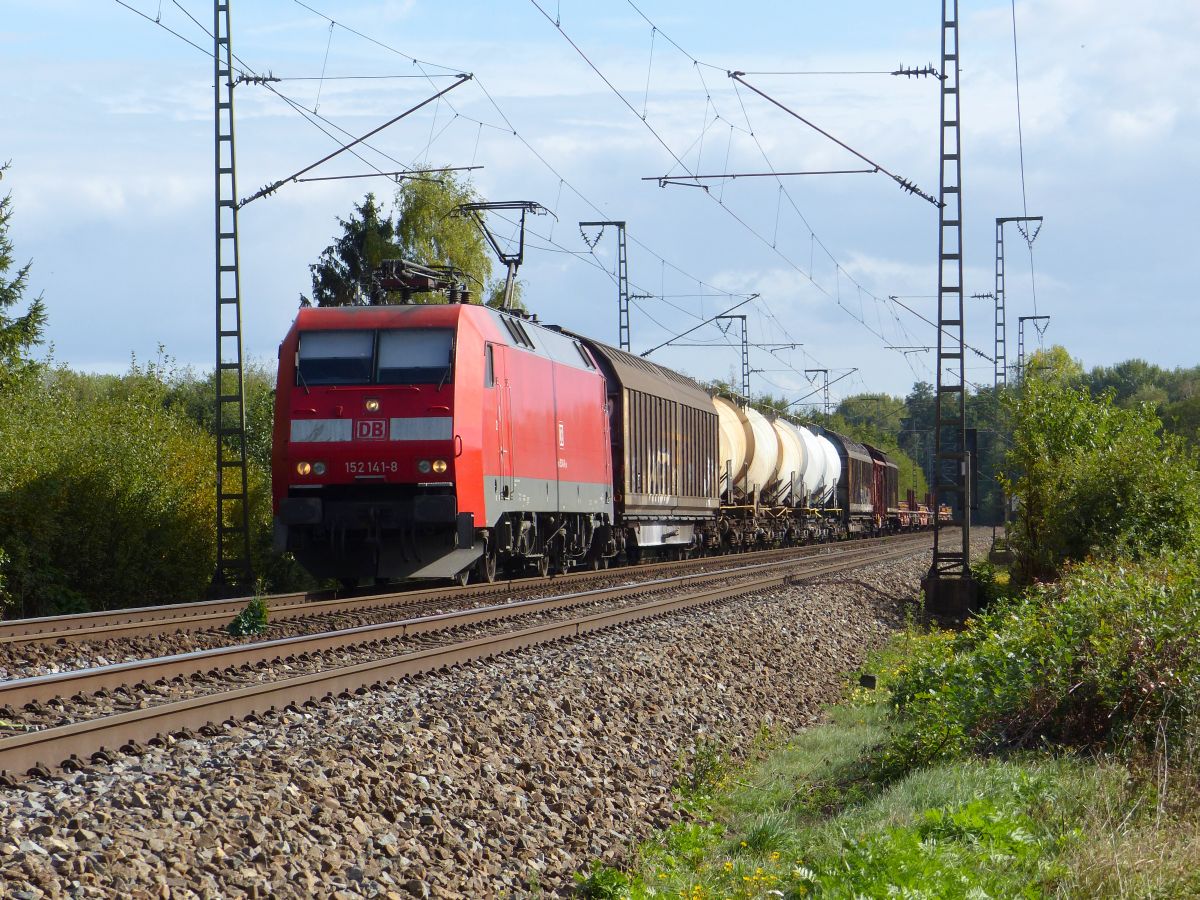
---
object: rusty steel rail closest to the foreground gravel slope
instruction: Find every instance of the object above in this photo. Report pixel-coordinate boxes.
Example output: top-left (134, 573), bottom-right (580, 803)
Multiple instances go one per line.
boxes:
top-left (0, 540), bottom-right (926, 785)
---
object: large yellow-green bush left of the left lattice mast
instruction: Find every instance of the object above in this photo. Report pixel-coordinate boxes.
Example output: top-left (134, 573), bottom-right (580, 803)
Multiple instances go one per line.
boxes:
top-left (0, 371), bottom-right (216, 616)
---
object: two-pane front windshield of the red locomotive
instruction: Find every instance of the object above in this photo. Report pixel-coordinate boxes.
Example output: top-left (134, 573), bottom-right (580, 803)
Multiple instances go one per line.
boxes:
top-left (296, 328), bottom-right (454, 386)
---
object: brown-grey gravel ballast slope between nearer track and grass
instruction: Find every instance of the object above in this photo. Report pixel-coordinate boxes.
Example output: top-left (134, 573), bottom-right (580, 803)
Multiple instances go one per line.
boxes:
top-left (0, 542), bottom-right (955, 898)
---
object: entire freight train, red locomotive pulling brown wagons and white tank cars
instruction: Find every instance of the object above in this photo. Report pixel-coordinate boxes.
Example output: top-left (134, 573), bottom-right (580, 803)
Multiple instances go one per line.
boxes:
top-left (272, 302), bottom-right (929, 586)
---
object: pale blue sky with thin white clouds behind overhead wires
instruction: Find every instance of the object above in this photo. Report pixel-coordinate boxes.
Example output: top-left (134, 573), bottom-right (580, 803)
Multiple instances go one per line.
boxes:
top-left (0, 0), bottom-right (1200, 407)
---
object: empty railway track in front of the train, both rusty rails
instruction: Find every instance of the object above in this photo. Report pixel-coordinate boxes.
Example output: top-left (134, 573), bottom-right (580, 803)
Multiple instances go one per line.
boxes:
top-left (0, 539), bottom-right (925, 784)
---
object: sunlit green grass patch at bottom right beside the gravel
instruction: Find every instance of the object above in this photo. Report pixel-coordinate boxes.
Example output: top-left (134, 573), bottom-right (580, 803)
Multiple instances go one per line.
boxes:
top-left (581, 703), bottom-right (1171, 900)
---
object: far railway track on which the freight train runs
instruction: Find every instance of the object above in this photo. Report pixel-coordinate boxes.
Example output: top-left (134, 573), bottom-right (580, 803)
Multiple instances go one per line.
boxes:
top-left (0, 535), bottom-right (914, 653)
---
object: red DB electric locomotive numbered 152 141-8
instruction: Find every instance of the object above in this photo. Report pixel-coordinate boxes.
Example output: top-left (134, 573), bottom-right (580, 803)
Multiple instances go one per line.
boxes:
top-left (272, 302), bottom-right (613, 584)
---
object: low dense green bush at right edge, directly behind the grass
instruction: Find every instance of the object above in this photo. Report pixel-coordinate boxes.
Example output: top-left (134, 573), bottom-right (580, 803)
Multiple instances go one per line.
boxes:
top-left (888, 557), bottom-right (1200, 769)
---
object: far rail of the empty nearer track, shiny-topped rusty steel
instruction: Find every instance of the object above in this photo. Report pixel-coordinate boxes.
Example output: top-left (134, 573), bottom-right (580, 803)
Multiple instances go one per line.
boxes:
top-left (0, 547), bottom-right (926, 709)
